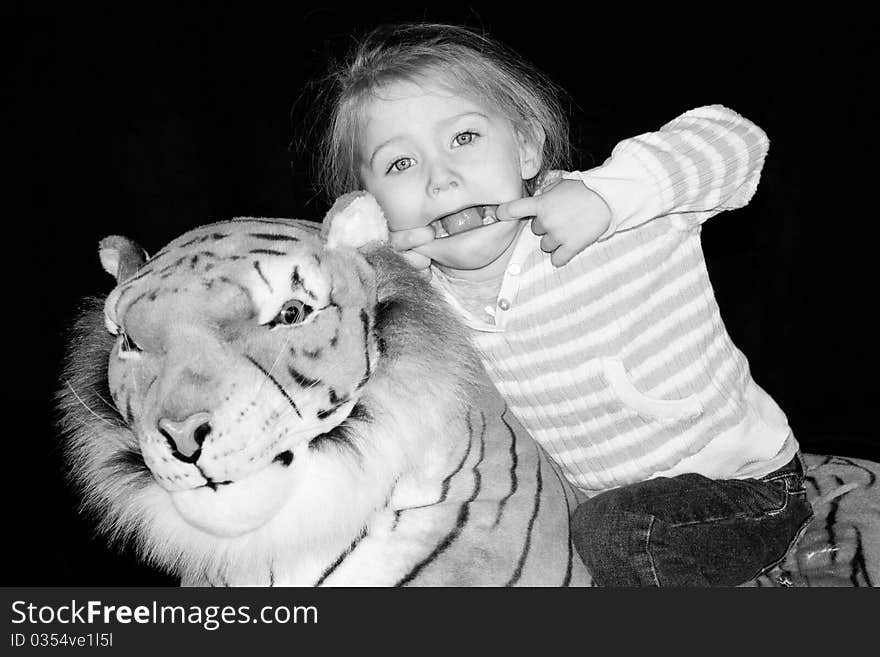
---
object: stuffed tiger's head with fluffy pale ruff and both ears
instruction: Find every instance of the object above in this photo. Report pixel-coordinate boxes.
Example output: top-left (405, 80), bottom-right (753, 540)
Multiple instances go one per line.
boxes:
top-left (61, 195), bottom-right (481, 574)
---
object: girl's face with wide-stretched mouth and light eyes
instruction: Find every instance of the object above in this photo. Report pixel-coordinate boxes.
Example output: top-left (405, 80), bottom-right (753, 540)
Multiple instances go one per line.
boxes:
top-left (358, 82), bottom-right (540, 270)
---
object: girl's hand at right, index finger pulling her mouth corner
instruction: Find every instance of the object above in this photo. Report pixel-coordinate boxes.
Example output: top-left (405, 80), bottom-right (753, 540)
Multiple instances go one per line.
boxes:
top-left (496, 180), bottom-right (611, 267)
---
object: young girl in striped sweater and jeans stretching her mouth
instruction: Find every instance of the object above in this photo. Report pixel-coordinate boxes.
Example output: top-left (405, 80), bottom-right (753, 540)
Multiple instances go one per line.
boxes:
top-left (312, 24), bottom-right (811, 586)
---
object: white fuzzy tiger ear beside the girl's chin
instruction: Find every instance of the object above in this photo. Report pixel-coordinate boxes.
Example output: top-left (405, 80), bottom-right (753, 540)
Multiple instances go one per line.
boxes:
top-left (321, 191), bottom-right (388, 249)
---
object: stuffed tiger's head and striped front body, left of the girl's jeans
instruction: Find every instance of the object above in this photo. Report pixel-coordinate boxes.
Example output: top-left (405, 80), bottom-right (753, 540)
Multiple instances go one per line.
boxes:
top-left (60, 195), bottom-right (590, 586)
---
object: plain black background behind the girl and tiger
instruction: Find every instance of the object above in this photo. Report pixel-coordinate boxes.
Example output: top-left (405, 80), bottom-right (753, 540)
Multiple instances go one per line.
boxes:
top-left (0, 2), bottom-right (880, 586)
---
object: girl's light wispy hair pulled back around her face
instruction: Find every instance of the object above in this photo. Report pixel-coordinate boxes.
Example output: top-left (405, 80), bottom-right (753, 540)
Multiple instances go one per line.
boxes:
top-left (315, 23), bottom-right (570, 200)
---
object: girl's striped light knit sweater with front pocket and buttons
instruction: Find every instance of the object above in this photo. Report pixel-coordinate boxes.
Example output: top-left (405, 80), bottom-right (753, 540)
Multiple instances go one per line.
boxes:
top-left (433, 106), bottom-right (797, 492)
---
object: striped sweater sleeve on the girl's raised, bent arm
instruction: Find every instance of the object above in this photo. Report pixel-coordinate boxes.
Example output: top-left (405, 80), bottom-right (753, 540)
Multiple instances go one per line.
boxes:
top-left (564, 105), bottom-right (769, 239)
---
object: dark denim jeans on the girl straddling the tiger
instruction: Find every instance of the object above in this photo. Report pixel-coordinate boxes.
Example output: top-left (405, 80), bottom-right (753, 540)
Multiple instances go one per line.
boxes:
top-left (572, 455), bottom-right (813, 586)
